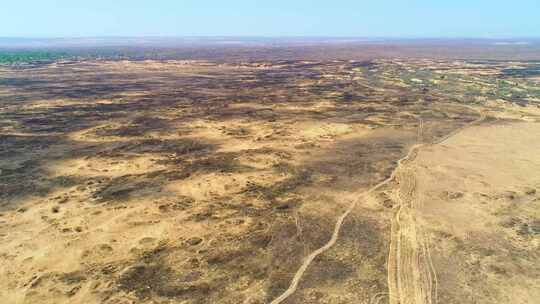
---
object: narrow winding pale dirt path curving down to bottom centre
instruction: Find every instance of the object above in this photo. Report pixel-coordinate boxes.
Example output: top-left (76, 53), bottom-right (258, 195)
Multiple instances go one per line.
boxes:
top-left (270, 105), bottom-right (485, 304)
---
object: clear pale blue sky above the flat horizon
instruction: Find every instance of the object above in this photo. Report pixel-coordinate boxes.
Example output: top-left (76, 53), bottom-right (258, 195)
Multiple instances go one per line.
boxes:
top-left (0, 0), bottom-right (540, 38)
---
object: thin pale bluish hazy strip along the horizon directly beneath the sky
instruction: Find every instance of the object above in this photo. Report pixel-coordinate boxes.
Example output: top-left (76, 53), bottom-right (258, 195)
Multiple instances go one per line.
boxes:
top-left (0, 36), bottom-right (540, 48)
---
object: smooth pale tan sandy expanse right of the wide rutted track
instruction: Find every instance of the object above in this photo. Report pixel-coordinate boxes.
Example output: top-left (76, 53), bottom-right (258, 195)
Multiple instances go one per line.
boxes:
top-left (400, 122), bottom-right (540, 303)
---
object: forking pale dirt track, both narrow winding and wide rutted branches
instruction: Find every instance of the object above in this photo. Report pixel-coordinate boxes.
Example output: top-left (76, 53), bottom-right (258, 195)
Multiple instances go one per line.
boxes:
top-left (270, 108), bottom-right (485, 304)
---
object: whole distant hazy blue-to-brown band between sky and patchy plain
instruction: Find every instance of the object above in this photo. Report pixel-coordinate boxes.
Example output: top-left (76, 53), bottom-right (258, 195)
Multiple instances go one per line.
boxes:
top-left (0, 37), bottom-right (540, 61)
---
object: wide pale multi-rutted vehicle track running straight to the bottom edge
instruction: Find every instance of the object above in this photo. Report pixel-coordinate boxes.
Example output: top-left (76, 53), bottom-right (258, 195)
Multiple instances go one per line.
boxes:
top-left (388, 113), bottom-right (485, 304)
